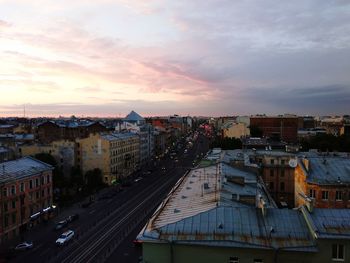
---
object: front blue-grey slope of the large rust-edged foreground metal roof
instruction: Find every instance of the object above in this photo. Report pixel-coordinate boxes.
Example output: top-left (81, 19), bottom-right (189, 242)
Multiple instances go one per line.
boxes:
top-left (139, 206), bottom-right (316, 251)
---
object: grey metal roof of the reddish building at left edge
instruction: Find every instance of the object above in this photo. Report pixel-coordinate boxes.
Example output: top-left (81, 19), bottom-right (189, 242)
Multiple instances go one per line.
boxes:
top-left (0, 157), bottom-right (53, 183)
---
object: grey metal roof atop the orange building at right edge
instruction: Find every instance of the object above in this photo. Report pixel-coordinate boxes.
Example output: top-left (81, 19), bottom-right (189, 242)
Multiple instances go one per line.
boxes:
top-left (307, 157), bottom-right (350, 184)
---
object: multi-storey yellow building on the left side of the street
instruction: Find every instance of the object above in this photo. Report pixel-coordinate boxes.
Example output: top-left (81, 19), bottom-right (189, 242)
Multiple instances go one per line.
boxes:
top-left (77, 133), bottom-right (140, 184)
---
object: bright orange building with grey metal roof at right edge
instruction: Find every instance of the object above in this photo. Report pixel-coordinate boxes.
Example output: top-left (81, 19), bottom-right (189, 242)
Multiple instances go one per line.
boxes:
top-left (295, 153), bottom-right (350, 208)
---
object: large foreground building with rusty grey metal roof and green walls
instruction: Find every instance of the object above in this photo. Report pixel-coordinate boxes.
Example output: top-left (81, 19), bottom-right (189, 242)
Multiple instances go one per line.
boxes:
top-left (137, 152), bottom-right (350, 263)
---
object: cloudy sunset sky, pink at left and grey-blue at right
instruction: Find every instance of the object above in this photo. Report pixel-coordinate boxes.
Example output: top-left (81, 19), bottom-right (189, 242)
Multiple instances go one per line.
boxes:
top-left (0, 0), bottom-right (350, 117)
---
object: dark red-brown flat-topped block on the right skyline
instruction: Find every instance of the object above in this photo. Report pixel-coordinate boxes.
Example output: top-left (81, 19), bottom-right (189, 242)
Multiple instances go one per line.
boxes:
top-left (250, 116), bottom-right (298, 143)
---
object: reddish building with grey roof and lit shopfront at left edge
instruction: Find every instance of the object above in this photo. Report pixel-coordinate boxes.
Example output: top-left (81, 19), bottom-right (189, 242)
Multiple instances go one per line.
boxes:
top-left (0, 157), bottom-right (53, 242)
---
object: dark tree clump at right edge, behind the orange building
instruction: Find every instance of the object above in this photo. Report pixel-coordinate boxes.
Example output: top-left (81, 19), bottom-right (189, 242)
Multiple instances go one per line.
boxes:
top-left (300, 134), bottom-right (350, 152)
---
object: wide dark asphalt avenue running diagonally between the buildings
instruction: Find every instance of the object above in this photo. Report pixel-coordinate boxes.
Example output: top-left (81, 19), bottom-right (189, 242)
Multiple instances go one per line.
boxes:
top-left (11, 136), bottom-right (208, 263)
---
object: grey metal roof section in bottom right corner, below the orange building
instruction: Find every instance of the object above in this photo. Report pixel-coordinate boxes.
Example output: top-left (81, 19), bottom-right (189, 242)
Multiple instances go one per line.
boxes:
top-left (309, 208), bottom-right (350, 239)
